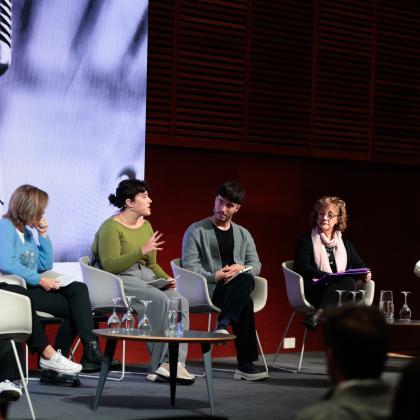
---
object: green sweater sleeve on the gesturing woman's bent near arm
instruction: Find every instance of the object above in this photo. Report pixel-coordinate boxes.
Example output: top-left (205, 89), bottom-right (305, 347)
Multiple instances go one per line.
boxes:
top-left (97, 223), bottom-right (144, 274)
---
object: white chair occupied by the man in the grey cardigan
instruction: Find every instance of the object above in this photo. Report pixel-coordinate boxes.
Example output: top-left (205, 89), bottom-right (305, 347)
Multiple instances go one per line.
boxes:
top-left (171, 258), bottom-right (268, 372)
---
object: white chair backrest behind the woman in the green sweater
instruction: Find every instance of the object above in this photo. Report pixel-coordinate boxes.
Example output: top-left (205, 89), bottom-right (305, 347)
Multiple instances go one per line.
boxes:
top-left (79, 256), bottom-right (127, 308)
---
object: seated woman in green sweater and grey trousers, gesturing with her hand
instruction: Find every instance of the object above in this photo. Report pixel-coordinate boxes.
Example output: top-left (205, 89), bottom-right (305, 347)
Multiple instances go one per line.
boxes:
top-left (92, 179), bottom-right (194, 383)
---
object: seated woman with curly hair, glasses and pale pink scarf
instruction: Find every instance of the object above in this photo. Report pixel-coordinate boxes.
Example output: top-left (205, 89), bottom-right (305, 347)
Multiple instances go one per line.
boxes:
top-left (295, 197), bottom-right (371, 331)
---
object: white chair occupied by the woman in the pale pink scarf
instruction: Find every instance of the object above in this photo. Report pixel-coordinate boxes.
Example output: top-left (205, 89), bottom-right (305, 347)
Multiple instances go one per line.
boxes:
top-left (272, 260), bottom-right (375, 372)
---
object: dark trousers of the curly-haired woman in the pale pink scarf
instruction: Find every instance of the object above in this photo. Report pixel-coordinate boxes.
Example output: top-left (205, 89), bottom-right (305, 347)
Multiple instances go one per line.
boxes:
top-left (305, 277), bottom-right (356, 309)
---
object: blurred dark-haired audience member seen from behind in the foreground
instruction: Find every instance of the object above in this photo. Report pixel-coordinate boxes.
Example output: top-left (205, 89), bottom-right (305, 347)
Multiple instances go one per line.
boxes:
top-left (294, 305), bottom-right (392, 420)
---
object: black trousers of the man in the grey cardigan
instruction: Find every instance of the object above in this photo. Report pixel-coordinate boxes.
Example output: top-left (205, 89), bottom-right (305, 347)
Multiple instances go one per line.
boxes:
top-left (212, 273), bottom-right (258, 366)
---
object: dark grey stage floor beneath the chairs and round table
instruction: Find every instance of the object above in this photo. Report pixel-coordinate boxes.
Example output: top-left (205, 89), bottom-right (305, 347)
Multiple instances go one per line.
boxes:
top-left (8, 353), bottom-right (408, 420)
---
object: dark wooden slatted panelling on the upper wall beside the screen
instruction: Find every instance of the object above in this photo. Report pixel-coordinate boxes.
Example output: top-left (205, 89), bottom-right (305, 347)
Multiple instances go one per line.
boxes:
top-left (146, 0), bottom-right (420, 164)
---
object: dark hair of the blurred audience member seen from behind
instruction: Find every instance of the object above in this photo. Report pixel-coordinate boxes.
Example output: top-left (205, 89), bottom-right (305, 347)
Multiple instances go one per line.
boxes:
top-left (324, 305), bottom-right (388, 379)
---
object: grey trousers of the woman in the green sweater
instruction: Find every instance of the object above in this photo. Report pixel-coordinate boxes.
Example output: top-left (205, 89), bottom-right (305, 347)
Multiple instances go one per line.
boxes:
top-left (119, 264), bottom-right (190, 372)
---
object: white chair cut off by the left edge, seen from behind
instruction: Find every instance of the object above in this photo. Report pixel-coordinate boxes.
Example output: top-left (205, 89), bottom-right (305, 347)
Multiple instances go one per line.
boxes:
top-left (0, 289), bottom-right (35, 419)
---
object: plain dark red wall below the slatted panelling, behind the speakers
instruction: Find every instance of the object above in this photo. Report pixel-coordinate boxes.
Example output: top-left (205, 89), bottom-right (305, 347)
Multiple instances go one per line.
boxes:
top-left (145, 146), bottom-right (420, 356)
